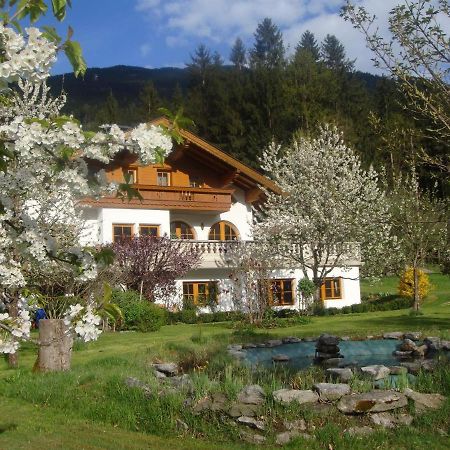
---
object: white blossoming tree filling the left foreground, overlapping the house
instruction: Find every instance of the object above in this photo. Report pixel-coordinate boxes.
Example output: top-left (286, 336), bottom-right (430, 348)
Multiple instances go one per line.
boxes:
top-left (0, 0), bottom-right (172, 370)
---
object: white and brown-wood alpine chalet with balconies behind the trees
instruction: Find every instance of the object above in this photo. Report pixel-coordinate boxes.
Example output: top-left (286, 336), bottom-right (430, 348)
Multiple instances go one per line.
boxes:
top-left (84, 119), bottom-right (361, 311)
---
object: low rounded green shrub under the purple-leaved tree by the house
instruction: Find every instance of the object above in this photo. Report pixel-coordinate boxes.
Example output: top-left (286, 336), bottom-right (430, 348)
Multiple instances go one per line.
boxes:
top-left (112, 290), bottom-right (167, 333)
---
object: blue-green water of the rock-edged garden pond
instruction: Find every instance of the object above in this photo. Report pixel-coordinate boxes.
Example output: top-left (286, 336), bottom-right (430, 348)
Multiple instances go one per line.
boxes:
top-left (244, 339), bottom-right (408, 369)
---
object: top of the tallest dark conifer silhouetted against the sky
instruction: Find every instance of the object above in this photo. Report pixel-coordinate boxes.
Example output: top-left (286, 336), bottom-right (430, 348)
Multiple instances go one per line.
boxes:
top-left (250, 18), bottom-right (286, 69)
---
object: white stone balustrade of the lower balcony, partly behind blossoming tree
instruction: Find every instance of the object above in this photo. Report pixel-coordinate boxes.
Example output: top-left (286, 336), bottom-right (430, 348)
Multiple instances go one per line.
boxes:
top-left (179, 240), bottom-right (361, 268)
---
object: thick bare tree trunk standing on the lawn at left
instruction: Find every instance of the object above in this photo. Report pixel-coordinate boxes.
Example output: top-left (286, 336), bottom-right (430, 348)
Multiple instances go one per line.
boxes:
top-left (35, 319), bottom-right (73, 372)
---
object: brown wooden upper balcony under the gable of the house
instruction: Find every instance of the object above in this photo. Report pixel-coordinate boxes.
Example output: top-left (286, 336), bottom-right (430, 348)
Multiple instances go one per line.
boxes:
top-left (86, 184), bottom-right (233, 212)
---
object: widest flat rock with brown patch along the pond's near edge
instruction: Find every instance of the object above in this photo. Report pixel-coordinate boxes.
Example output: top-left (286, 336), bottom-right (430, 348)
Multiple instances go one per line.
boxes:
top-left (337, 391), bottom-right (408, 414)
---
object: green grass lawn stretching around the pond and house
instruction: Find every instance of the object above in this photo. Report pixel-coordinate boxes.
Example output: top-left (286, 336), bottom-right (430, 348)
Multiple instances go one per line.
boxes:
top-left (0, 274), bottom-right (450, 450)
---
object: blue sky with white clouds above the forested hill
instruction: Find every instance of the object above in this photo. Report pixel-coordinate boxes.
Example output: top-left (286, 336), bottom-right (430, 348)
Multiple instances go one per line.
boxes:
top-left (32, 0), bottom-right (398, 73)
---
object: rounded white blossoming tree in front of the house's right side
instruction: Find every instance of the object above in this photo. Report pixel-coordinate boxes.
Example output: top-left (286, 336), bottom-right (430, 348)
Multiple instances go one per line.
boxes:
top-left (253, 126), bottom-right (389, 306)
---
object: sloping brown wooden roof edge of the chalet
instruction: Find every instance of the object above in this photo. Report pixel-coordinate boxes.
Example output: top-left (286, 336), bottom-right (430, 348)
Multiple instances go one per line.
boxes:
top-left (150, 117), bottom-right (281, 193)
